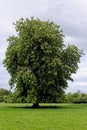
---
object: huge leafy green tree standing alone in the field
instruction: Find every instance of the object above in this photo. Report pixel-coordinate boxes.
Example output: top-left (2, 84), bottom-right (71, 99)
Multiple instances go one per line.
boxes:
top-left (4, 18), bottom-right (82, 104)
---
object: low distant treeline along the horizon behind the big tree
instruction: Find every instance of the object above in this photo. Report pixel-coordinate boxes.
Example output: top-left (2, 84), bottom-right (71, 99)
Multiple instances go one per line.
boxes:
top-left (0, 88), bottom-right (87, 103)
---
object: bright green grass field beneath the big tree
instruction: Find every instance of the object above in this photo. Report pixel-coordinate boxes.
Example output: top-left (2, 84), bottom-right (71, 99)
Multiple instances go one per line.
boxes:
top-left (0, 104), bottom-right (87, 130)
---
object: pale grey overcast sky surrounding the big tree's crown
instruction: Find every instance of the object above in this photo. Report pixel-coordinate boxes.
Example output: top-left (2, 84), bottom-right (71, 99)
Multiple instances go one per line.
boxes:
top-left (0, 0), bottom-right (87, 92)
